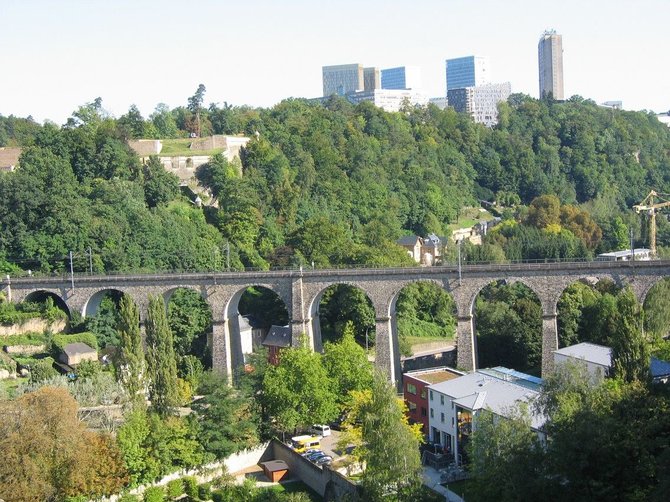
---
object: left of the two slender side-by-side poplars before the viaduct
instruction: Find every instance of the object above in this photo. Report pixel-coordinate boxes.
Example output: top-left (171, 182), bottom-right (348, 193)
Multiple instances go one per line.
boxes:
top-left (114, 295), bottom-right (147, 405)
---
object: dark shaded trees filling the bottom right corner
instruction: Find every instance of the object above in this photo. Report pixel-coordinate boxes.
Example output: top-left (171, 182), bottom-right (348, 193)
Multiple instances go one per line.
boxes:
top-left (470, 365), bottom-right (670, 501)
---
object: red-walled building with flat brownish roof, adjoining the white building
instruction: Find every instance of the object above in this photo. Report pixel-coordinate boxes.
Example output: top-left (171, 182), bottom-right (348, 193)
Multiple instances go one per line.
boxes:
top-left (402, 366), bottom-right (465, 438)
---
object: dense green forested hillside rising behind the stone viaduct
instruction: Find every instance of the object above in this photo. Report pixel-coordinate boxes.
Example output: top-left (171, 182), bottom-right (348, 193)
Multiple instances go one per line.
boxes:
top-left (0, 94), bottom-right (670, 271)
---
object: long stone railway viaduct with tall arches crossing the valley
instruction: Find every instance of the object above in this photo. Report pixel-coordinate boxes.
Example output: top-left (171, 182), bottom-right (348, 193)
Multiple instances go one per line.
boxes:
top-left (0, 260), bottom-right (670, 381)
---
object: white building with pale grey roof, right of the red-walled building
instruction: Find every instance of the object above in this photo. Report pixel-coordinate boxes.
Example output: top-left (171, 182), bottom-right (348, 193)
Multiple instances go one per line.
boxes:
top-left (428, 367), bottom-right (545, 465)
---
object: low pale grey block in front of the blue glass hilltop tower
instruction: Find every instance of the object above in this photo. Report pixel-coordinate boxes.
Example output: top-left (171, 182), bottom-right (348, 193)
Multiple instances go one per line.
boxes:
top-left (447, 82), bottom-right (512, 127)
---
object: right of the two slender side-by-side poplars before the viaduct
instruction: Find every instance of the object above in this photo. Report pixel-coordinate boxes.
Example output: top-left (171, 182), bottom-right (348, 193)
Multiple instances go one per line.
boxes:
top-left (146, 296), bottom-right (179, 416)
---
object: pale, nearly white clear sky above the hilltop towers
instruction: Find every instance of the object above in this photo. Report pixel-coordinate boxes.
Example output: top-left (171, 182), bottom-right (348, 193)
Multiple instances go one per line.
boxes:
top-left (0, 0), bottom-right (670, 123)
